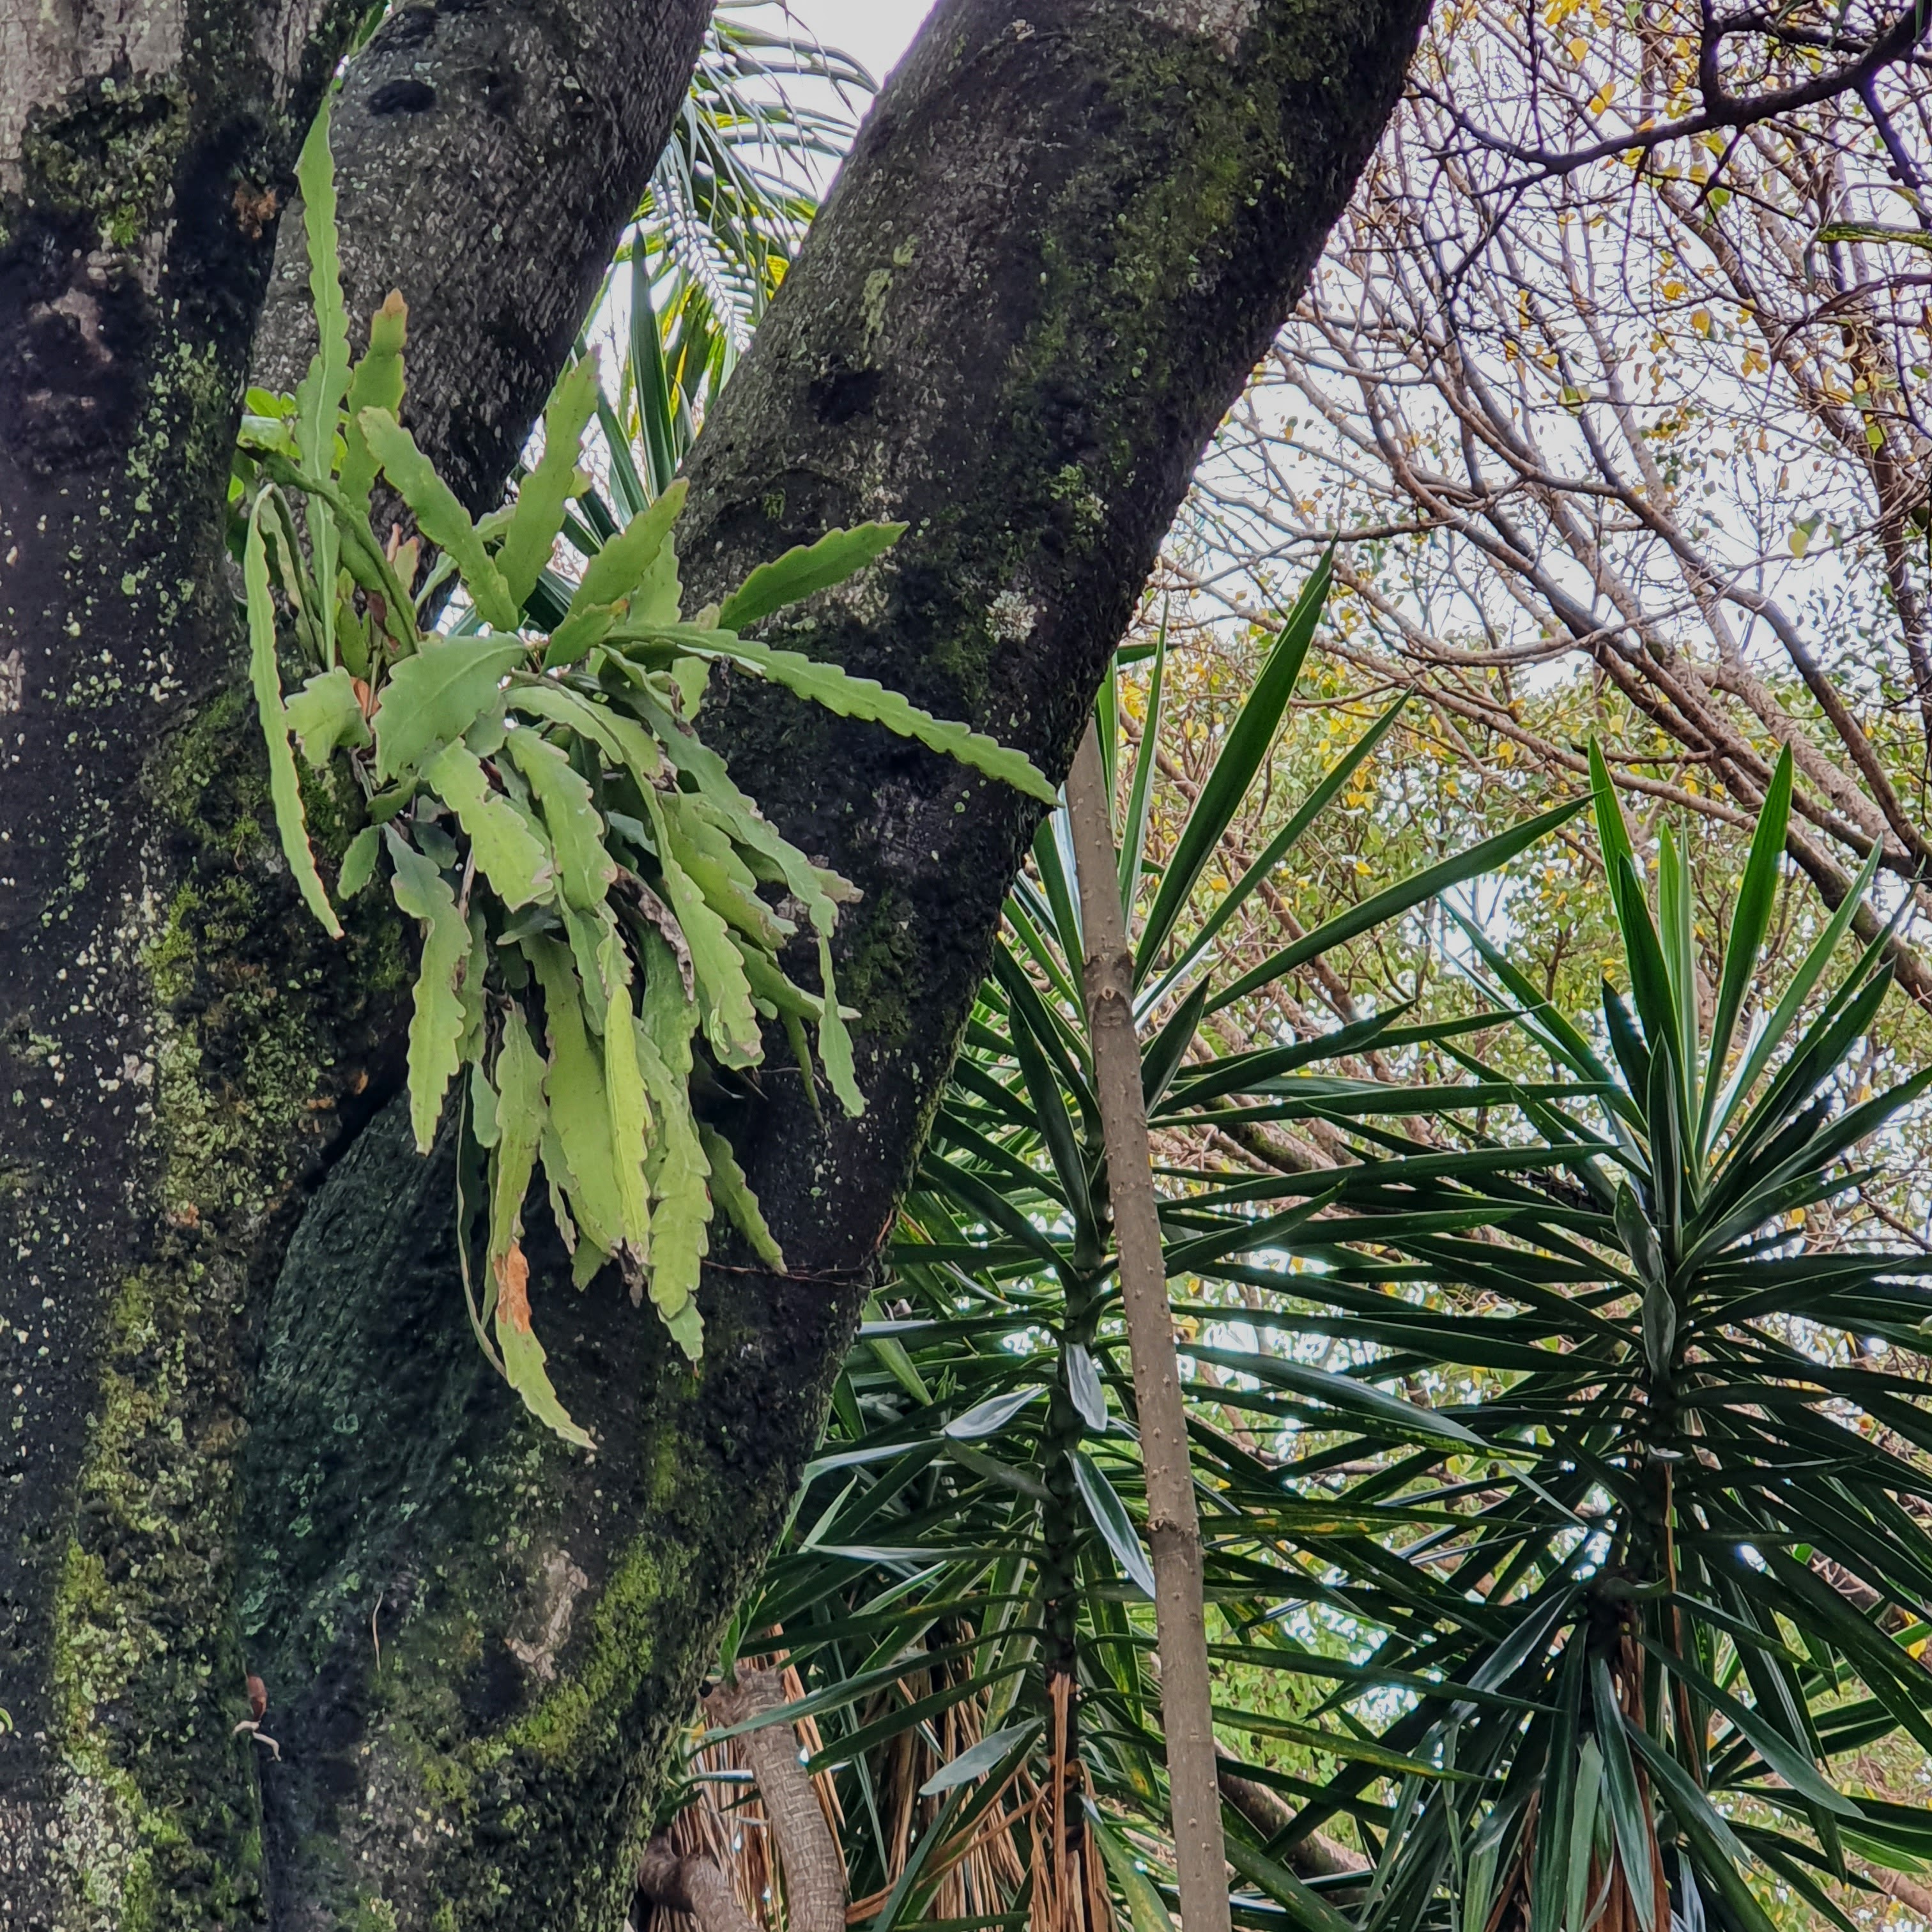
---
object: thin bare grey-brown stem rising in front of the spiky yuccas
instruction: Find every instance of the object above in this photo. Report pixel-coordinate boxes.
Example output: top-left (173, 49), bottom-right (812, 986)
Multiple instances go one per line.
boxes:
top-left (1066, 719), bottom-right (1229, 1932)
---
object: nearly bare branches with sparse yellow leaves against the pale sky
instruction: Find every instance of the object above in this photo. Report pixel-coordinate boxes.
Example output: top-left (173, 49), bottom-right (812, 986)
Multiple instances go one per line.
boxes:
top-left (1149, 6), bottom-right (1932, 1238)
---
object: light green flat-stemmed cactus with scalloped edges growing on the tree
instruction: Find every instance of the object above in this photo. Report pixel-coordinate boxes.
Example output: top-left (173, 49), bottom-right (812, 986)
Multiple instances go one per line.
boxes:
top-left (241, 98), bottom-right (1051, 1441)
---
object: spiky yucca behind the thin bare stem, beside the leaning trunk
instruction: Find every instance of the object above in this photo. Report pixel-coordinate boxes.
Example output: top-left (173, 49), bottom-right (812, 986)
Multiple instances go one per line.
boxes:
top-left (703, 570), bottom-right (1575, 1932)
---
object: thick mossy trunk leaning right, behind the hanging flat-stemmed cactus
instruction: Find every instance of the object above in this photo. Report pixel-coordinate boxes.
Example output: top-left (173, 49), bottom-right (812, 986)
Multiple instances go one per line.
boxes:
top-left (243, 0), bottom-right (1420, 1924)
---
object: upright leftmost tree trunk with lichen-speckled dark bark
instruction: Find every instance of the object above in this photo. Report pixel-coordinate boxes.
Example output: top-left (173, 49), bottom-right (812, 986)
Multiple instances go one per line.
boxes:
top-left (0, 0), bottom-right (388, 1928)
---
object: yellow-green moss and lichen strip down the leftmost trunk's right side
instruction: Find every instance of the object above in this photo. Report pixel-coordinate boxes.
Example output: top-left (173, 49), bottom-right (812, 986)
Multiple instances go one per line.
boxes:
top-left (23, 696), bottom-right (400, 1926)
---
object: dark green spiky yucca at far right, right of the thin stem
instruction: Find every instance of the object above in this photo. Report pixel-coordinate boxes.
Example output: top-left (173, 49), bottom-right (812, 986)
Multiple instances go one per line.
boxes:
top-left (1159, 755), bottom-right (1932, 1932)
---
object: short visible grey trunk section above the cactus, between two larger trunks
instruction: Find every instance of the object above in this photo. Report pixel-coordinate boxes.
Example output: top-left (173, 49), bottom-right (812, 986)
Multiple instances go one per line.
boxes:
top-left (253, 0), bottom-right (711, 514)
